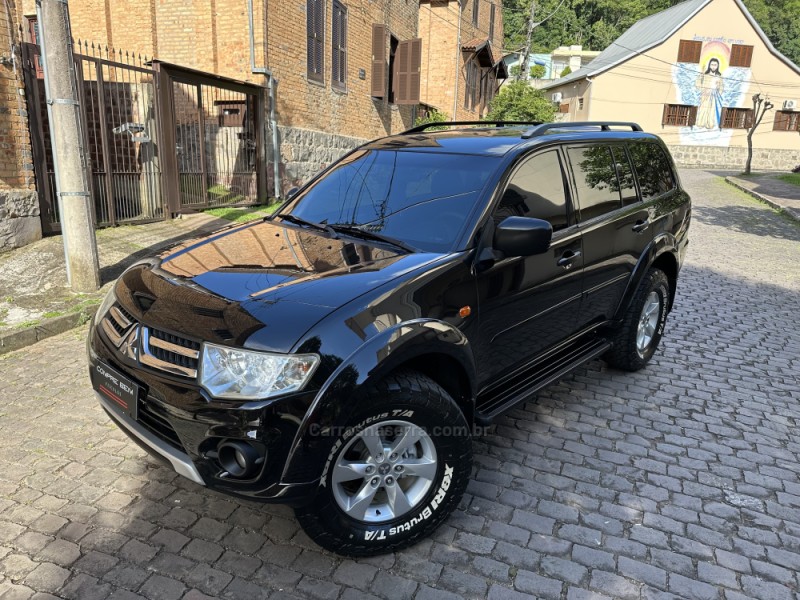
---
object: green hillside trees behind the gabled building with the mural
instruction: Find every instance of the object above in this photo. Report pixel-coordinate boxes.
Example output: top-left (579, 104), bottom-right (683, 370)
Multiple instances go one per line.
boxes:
top-left (503, 0), bottom-right (800, 64)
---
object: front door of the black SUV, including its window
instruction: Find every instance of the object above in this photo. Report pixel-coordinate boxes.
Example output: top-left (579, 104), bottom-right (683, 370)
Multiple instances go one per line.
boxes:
top-left (477, 149), bottom-right (583, 382)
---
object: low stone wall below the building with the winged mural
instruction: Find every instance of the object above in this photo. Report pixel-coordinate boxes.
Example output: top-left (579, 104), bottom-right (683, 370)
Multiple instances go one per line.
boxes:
top-left (669, 146), bottom-right (800, 171)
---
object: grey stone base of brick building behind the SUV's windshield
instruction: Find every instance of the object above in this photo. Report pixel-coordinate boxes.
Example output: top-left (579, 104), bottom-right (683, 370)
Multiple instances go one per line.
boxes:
top-left (278, 127), bottom-right (367, 192)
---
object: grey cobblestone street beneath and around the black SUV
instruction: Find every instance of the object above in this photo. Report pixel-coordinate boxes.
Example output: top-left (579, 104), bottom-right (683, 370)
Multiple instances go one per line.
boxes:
top-left (0, 170), bottom-right (800, 600)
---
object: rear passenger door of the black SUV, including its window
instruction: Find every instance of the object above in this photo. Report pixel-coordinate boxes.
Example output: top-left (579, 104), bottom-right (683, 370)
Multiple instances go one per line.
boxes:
top-left (567, 143), bottom-right (650, 327)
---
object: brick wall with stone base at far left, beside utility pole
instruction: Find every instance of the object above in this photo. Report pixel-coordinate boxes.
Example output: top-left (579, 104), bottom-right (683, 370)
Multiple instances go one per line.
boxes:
top-left (0, 0), bottom-right (42, 251)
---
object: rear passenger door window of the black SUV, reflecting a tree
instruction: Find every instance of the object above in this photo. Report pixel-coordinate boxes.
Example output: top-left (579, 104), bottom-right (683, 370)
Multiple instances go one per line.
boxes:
top-left (568, 146), bottom-right (622, 221)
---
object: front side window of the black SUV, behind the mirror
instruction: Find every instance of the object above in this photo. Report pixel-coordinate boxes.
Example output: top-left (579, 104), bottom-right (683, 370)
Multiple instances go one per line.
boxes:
top-left (494, 150), bottom-right (567, 231)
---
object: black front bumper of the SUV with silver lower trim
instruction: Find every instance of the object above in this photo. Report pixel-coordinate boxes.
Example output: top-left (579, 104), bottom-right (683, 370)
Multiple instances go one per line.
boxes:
top-left (87, 317), bottom-right (321, 505)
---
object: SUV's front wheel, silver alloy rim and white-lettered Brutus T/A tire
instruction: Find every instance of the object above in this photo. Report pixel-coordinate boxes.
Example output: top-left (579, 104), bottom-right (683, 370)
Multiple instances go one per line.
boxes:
top-left (295, 371), bottom-right (472, 557)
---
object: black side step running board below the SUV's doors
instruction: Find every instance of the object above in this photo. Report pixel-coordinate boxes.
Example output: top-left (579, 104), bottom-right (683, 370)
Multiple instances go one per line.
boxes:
top-left (475, 338), bottom-right (611, 426)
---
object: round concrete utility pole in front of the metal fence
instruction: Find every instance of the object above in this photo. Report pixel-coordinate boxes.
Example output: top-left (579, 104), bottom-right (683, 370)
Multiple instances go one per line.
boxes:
top-left (36, 0), bottom-right (100, 292)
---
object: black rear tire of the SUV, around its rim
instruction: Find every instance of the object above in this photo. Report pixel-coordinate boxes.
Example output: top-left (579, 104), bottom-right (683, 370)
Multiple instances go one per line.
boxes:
top-left (603, 269), bottom-right (670, 371)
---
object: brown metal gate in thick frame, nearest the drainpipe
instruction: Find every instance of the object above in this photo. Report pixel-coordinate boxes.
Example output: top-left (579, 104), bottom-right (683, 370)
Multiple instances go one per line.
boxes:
top-left (153, 61), bottom-right (267, 212)
